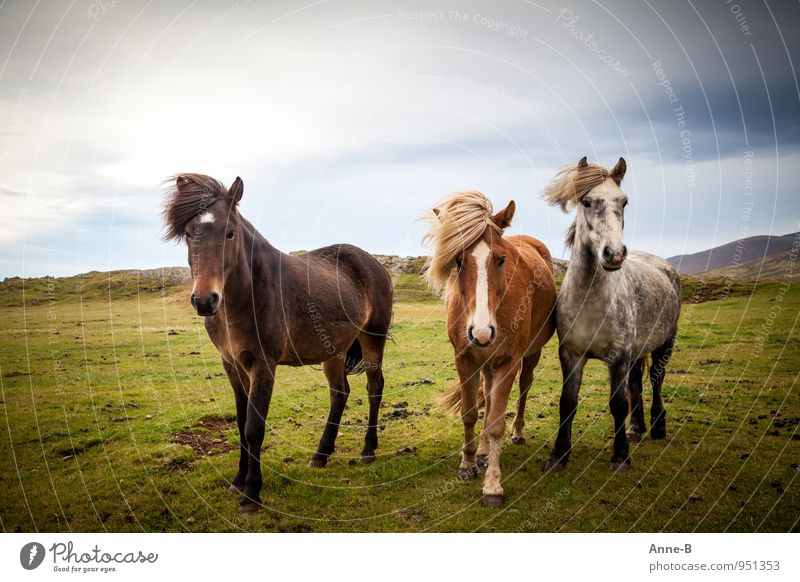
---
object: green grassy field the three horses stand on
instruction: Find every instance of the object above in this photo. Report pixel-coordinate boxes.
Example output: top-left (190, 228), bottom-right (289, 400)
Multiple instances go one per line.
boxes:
top-left (0, 273), bottom-right (800, 532)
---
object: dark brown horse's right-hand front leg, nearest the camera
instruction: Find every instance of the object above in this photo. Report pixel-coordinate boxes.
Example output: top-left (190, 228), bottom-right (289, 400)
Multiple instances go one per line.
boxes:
top-left (239, 361), bottom-right (275, 513)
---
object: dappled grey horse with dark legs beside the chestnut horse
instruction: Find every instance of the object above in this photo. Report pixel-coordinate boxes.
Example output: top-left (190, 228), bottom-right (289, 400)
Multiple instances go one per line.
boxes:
top-left (544, 157), bottom-right (681, 471)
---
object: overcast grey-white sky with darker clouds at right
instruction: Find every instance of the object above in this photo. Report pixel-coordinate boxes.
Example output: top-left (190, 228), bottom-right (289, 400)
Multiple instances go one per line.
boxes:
top-left (0, 0), bottom-right (800, 277)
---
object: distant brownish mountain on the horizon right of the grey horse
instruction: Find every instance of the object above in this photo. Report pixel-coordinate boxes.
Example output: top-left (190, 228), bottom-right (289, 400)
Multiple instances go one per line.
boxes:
top-left (667, 232), bottom-right (800, 279)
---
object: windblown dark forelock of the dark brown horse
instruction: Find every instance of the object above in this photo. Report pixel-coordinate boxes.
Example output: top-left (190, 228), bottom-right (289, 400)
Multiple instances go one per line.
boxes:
top-left (161, 173), bottom-right (226, 241)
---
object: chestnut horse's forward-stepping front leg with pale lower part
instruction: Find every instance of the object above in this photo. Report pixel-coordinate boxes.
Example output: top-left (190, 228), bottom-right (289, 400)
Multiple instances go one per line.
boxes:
top-left (482, 359), bottom-right (520, 507)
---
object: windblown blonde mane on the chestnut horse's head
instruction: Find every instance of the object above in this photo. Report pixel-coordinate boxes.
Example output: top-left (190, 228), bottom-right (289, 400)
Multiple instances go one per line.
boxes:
top-left (422, 190), bottom-right (502, 293)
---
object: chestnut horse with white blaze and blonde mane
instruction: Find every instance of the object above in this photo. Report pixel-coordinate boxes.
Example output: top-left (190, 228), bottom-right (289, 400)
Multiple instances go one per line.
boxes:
top-left (425, 191), bottom-right (556, 507)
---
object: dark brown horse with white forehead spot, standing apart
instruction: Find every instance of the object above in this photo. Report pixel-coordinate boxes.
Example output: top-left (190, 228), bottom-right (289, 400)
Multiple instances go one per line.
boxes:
top-left (163, 174), bottom-right (392, 513)
